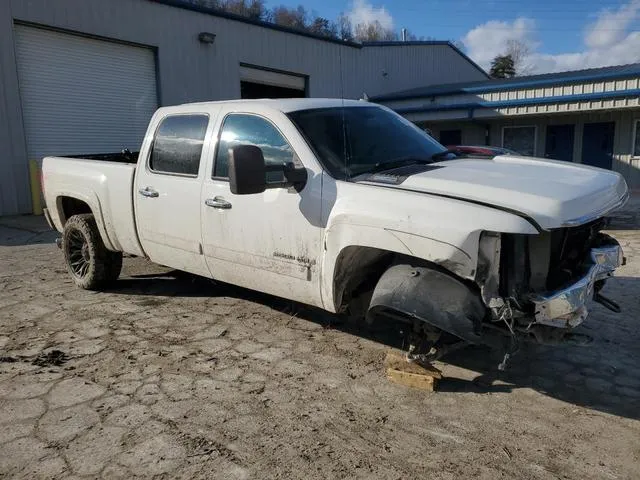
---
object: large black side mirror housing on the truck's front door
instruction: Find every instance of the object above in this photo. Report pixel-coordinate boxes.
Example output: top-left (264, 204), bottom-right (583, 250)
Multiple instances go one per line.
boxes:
top-left (229, 145), bottom-right (267, 195)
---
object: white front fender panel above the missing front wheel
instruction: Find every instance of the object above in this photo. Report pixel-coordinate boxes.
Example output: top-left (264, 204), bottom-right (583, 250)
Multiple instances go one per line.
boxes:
top-left (321, 179), bottom-right (538, 312)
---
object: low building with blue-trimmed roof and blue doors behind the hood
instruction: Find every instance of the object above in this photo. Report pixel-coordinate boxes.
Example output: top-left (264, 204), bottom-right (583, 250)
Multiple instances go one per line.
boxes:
top-left (372, 64), bottom-right (640, 189)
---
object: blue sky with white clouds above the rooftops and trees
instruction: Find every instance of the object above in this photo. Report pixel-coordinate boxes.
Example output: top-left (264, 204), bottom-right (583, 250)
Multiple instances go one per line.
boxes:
top-left (267, 0), bottom-right (640, 73)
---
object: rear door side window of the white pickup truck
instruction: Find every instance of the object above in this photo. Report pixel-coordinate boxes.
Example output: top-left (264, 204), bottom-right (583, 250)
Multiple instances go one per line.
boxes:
top-left (149, 115), bottom-right (209, 176)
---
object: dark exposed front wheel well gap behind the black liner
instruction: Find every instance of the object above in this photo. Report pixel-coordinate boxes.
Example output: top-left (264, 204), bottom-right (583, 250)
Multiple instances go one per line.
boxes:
top-left (333, 246), bottom-right (396, 312)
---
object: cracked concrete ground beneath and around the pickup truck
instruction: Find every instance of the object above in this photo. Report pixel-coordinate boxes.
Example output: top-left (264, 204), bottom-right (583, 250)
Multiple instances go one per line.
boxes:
top-left (0, 203), bottom-right (640, 479)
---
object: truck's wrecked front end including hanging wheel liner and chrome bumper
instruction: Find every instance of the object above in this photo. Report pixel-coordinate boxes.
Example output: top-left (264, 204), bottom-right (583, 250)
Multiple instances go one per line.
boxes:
top-left (368, 218), bottom-right (624, 366)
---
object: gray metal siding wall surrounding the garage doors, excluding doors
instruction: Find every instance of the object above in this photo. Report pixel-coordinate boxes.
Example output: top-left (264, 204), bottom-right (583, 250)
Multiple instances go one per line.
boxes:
top-left (0, 0), bottom-right (485, 215)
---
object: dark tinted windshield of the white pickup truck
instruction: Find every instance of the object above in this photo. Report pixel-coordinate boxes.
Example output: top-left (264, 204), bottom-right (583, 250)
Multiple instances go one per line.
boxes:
top-left (288, 106), bottom-right (446, 178)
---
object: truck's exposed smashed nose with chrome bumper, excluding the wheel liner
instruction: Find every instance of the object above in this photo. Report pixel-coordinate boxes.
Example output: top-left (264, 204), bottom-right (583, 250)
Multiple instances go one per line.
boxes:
top-left (476, 219), bottom-right (624, 344)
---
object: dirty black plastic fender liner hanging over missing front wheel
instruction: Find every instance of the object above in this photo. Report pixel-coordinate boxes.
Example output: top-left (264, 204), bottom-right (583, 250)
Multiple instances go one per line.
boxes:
top-left (367, 264), bottom-right (486, 344)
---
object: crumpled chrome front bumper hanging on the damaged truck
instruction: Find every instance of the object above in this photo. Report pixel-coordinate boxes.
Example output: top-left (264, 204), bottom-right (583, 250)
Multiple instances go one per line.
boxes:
top-left (533, 245), bottom-right (623, 328)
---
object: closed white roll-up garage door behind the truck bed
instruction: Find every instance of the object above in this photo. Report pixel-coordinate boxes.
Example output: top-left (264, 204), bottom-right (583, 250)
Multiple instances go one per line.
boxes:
top-left (15, 25), bottom-right (157, 160)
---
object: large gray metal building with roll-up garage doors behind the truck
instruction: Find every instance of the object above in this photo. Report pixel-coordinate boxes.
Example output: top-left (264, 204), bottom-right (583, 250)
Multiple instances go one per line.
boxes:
top-left (0, 0), bottom-right (487, 215)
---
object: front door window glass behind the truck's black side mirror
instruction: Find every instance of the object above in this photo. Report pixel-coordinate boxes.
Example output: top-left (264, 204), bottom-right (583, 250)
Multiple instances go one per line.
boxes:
top-left (213, 114), bottom-right (295, 183)
